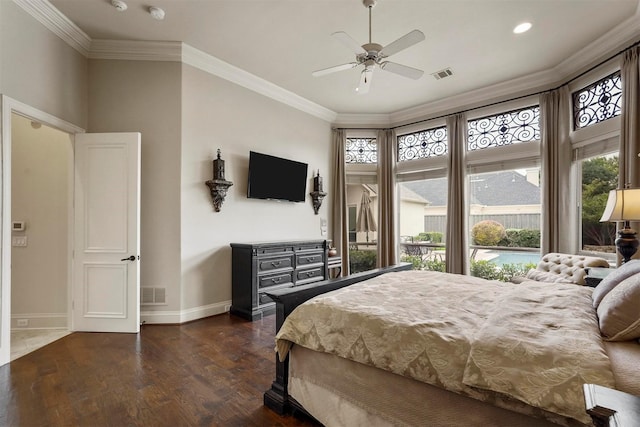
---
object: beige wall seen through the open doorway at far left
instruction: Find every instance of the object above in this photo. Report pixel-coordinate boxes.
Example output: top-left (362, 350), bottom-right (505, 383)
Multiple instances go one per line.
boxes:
top-left (11, 114), bottom-right (72, 328)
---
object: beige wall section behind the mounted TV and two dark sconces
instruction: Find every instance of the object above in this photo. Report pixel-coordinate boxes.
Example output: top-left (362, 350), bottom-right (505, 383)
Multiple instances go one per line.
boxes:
top-left (181, 65), bottom-right (331, 309)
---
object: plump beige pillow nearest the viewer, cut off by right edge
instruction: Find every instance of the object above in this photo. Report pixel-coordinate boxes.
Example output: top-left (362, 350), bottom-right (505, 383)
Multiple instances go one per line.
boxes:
top-left (598, 274), bottom-right (640, 341)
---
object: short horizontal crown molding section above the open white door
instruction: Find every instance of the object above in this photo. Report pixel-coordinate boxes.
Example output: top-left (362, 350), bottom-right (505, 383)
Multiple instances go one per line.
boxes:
top-left (88, 39), bottom-right (183, 62)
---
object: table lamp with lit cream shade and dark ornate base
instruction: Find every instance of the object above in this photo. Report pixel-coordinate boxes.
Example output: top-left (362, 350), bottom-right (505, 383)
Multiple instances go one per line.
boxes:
top-left (600, 188), bottom-right (640, 264)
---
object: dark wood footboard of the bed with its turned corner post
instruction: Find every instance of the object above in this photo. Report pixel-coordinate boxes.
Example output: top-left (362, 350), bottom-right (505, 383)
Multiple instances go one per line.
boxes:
top-left (264, 263), bottom-right (412, 414)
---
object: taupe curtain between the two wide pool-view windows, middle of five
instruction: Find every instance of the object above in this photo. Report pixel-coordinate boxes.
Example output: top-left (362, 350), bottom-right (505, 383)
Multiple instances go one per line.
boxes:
top-left (445, 113), bottom-right (469, 274)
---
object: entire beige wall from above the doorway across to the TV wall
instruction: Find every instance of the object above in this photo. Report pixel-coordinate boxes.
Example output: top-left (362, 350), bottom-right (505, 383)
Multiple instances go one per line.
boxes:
top-left (0, 4), bottom-right (332, 321)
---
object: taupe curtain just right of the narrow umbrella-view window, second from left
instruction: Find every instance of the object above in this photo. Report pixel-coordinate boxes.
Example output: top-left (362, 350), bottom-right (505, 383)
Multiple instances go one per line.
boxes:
top-left (377, 129), bottom-right (397, 267)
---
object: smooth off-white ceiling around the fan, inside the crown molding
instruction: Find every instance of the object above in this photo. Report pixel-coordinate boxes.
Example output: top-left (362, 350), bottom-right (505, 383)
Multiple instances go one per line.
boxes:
top-left (50, 0), bottom-right (640, 118)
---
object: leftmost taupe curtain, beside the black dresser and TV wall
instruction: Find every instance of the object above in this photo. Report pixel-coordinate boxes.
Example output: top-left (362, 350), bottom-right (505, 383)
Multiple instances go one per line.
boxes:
top-left (331, 129), bottom-right (349, 276)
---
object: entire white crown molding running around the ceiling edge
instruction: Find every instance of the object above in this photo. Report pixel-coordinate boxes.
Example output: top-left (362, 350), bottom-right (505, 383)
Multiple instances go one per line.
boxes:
top-left (17, 0), bottom-right (640, 127)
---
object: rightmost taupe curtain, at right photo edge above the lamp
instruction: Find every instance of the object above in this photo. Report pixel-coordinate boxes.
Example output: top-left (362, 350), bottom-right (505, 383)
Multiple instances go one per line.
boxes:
top-left (619, 46), bottom-right (640, 188)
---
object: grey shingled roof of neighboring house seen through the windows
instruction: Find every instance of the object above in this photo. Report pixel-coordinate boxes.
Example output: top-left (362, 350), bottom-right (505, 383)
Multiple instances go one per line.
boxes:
top-left (401, 171), bottom-right (540, 206)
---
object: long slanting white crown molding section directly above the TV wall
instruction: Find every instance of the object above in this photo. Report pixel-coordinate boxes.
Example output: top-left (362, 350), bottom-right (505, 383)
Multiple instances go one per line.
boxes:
top-left (182, 43), bottom-right (337, 122)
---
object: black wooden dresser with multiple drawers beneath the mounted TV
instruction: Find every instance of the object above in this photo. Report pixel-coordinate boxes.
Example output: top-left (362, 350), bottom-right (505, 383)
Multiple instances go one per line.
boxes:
top-left (231, 240), bottom-right (329, 320)
